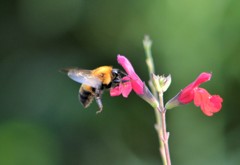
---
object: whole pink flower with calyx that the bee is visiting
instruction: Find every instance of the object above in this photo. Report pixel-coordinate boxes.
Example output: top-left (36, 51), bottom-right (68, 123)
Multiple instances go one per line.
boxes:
top-left (110, 55), bottom-right (159, 107)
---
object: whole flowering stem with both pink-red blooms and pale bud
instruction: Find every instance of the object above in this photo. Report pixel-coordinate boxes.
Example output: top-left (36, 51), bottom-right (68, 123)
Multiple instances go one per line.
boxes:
top-left (110, 36), bottom-right (223, 165)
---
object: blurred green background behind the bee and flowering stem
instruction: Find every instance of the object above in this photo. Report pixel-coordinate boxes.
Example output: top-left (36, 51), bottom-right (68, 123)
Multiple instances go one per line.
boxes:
top-left (0, 0), bottom-right (240, 165)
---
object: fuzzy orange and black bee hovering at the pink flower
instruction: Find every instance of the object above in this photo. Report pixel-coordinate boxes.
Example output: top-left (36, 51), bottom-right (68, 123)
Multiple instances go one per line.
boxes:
top-left (61, 66), bottom-right (127, 113)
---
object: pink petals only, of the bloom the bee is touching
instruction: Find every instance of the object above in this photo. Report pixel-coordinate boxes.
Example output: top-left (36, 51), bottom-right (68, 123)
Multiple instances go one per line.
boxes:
top-left (110, 55), bottom-right (144, 97)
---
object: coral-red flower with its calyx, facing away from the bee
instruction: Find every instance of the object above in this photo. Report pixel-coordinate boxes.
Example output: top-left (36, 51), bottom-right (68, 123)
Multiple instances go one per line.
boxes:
top-left (166, 72), bottom-right (223, 116)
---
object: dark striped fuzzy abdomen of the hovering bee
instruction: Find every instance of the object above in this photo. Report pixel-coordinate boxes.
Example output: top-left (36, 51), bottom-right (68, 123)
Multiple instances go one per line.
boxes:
top-left (78, 88), bottom-right (94, 108)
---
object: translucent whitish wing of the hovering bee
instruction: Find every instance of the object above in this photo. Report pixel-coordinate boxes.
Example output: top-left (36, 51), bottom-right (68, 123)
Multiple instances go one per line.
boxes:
top-left (61, 68), bottom-right (102, 88)
